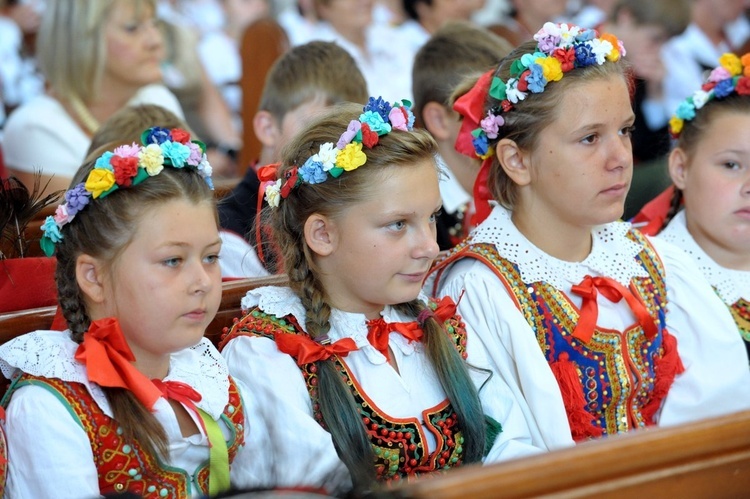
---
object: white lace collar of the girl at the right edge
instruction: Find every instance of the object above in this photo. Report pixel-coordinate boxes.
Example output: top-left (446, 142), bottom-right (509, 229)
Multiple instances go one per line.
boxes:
top-left (658, 210), bottom-right (750, 306)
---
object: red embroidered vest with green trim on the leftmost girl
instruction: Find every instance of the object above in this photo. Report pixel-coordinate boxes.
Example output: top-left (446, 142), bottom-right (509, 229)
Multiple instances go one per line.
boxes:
top-left (3, 374), bottom-right (245, 499)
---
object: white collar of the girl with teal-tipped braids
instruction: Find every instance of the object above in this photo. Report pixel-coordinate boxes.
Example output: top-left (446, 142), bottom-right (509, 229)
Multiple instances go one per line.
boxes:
top-left (242, 286), bottom-right (425, 364)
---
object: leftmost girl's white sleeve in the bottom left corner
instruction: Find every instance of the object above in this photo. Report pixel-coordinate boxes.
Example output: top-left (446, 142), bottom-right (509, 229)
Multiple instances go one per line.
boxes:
top-left (5, 386), bottom-right (99, 499)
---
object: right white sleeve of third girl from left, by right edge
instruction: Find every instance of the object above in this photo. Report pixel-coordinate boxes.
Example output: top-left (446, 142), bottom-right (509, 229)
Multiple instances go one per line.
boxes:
top-left (650, 238), bottom-right (750, 426)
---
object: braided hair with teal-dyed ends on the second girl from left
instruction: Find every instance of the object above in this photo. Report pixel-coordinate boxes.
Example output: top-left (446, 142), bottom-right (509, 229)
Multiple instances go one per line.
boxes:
top-left (270, 100), bottom-right (485, 487)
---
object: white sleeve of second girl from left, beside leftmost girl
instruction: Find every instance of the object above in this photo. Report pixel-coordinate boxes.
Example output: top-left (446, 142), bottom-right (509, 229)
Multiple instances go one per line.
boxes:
top-left (222, 336), bottom-right (349, 487)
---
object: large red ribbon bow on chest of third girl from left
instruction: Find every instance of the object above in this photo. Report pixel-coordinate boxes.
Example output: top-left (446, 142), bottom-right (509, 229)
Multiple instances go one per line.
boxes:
top-left (572, 275), bottom-right (658, 343)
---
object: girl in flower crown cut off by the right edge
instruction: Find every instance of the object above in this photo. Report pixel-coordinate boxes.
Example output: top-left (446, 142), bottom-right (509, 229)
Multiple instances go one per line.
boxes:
top-left (649, 53), bottom-right (750, 362)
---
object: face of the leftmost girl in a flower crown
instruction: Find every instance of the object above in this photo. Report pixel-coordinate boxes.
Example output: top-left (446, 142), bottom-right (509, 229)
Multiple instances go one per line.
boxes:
top-left (98, 200), bottom-right (221, 370)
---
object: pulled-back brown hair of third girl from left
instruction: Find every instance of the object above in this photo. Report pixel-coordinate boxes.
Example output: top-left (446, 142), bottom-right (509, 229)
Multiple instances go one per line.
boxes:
top-left (484, 41), bottom-right (633, 209)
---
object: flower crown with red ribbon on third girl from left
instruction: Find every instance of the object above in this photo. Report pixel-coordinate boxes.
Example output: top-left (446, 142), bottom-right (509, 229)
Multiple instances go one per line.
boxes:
top-left (454, 22), bottom-right (625, 159)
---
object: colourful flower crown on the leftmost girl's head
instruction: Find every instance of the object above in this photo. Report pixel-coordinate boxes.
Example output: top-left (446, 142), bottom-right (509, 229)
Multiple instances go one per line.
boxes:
top-left (40, 127), bottom-right (214, 256)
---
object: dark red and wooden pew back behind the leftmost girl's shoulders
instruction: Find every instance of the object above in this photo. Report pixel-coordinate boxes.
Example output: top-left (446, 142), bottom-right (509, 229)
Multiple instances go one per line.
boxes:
top-left (0, 275), bottom-right (288, 343)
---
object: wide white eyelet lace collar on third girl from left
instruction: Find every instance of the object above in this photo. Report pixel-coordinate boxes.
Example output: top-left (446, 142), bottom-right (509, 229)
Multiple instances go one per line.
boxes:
top-left (468, 203), bottom-right (648, 289)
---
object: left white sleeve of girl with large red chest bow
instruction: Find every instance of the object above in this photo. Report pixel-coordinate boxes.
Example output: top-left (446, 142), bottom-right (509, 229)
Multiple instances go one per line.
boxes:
top-left (436, 259), bottom-right (574, 461)
